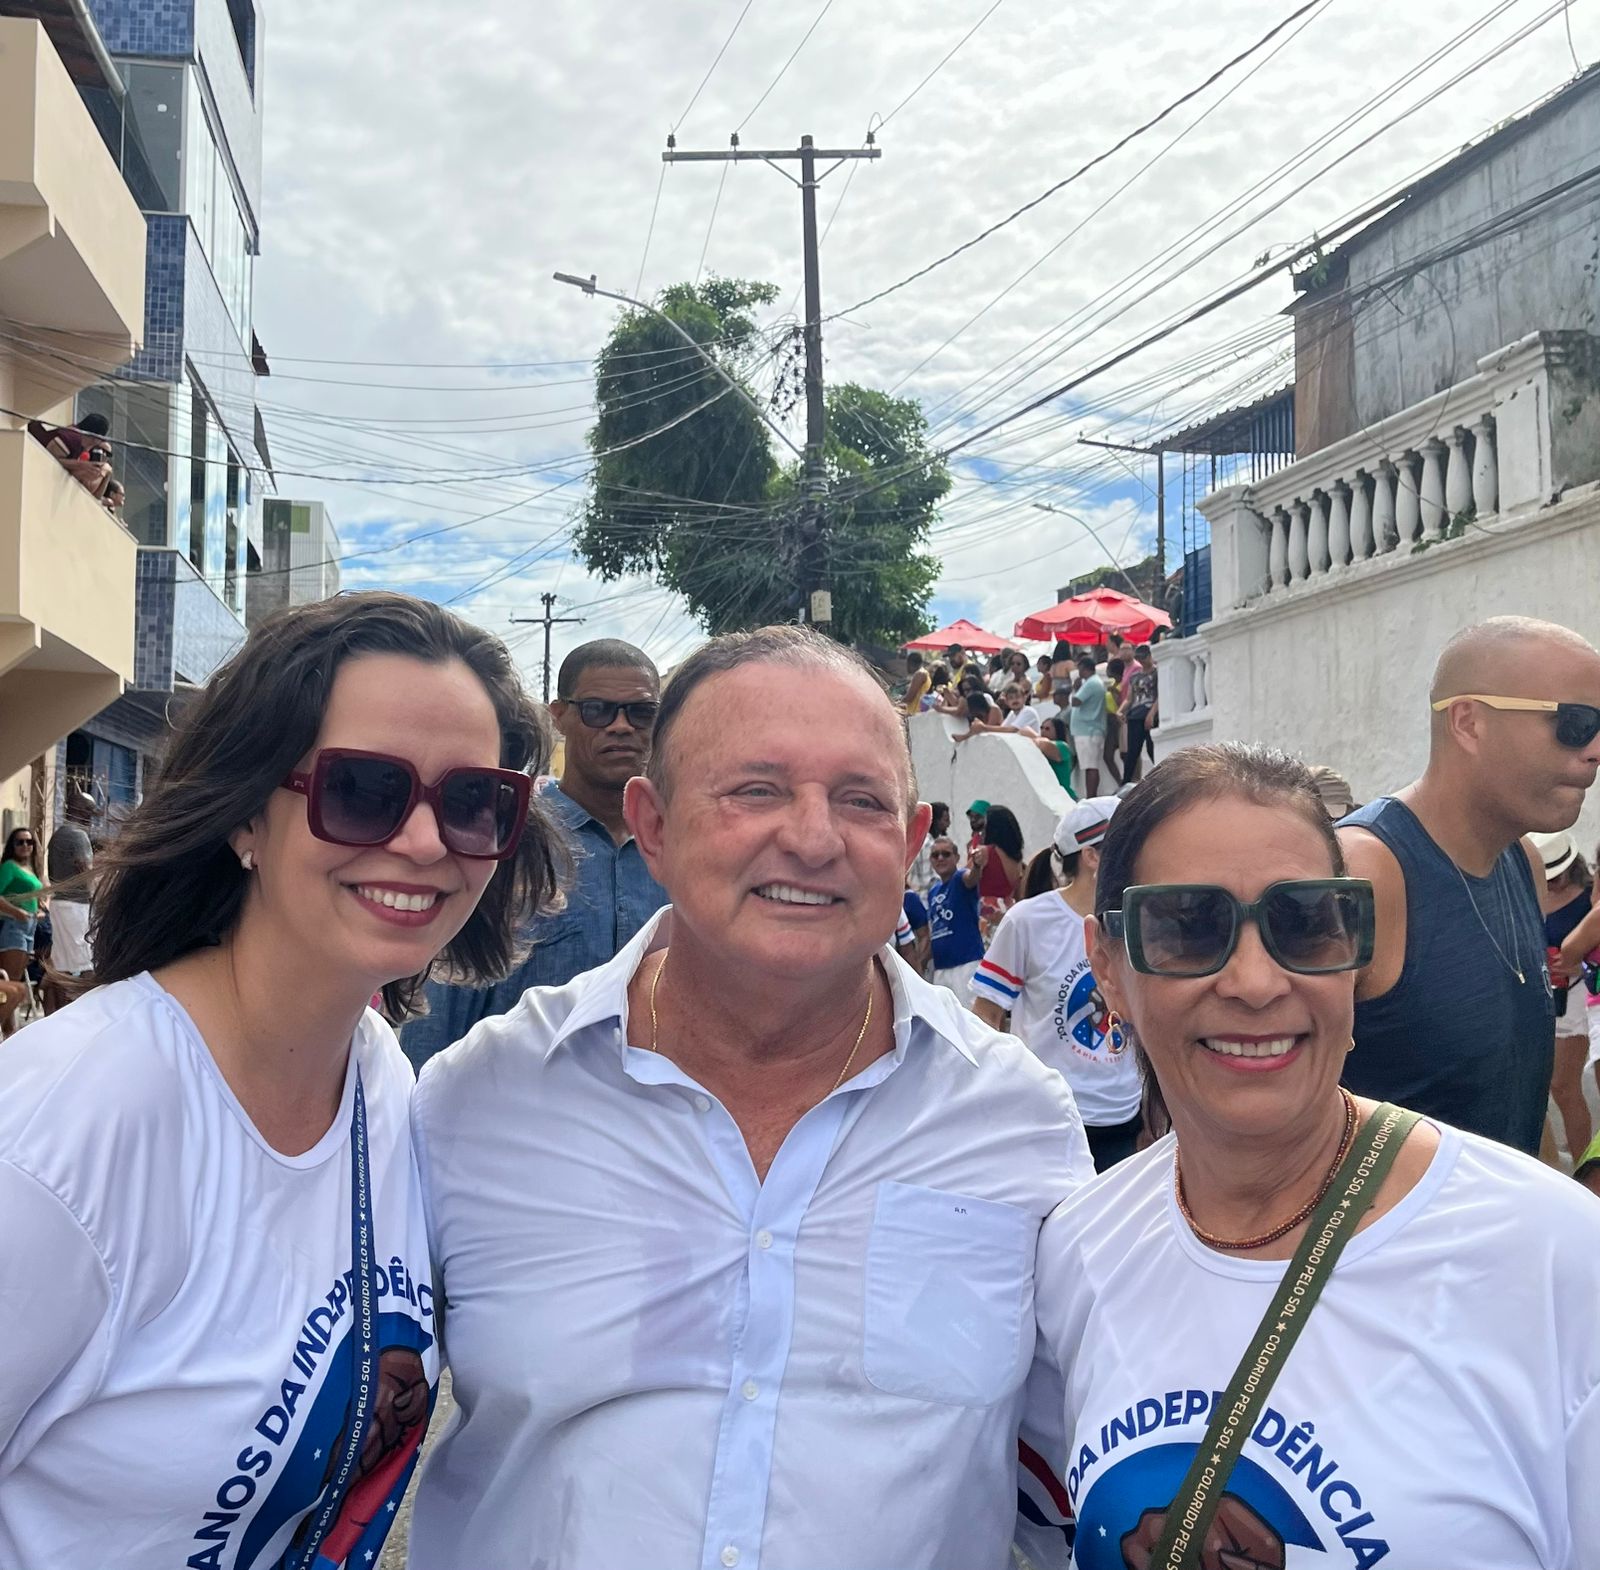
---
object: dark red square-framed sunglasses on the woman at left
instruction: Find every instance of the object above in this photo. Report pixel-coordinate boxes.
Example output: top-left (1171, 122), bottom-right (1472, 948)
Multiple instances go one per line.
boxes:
top-left (283, 747), bottom-right (533, 861)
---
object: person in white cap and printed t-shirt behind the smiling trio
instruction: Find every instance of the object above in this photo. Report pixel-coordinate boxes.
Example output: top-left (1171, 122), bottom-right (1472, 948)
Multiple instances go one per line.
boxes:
top-left (970, 795), bottom-right (1142, 1171)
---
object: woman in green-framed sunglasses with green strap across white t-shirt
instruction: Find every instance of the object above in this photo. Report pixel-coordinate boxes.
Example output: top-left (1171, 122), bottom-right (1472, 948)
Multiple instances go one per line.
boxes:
top-left (1035, 744), bottom-right (1600, 1570)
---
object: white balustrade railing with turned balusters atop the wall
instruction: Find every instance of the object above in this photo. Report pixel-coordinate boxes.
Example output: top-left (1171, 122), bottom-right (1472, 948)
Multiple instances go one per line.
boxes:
top-left (1200, 333), bottom-right (1600, 616)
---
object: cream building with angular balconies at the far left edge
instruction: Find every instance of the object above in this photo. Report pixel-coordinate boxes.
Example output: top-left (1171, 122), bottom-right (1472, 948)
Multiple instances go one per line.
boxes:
top-left (0, 9), bottom-right (146, 834)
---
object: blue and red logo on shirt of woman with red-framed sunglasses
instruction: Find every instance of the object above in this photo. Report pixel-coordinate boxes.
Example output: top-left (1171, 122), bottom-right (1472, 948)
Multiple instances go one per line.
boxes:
top-left (184, 1256), bottom-right (438, 1570)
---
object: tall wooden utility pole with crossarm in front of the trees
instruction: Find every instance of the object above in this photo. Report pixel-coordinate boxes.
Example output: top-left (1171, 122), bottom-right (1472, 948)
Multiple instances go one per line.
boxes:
top-left (661, 131), bottom-right (883, 623)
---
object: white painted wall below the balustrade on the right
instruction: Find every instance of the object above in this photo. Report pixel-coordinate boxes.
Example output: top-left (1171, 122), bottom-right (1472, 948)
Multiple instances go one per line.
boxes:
top-left (1171, 485), bottom-right (1600, 856)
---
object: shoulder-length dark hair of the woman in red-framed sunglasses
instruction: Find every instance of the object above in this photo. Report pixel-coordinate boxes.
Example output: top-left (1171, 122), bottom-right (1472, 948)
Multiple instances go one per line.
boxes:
top-left (93, 591), bottom-right (565, 1024)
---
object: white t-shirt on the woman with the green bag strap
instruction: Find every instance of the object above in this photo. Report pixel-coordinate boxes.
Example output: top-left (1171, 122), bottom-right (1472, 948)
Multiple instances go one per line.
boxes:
top-left (1035, 1128), bottom-right (1600, 1570)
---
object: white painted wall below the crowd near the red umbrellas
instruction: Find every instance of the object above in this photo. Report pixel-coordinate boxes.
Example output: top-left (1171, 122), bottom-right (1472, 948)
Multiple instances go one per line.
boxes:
top-left (906, 714), bottom-right (1072, 856)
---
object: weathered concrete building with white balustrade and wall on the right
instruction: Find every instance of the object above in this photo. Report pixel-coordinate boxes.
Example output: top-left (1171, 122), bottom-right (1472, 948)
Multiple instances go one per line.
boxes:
top-left (1157, 70), bottom-right (1600, 853)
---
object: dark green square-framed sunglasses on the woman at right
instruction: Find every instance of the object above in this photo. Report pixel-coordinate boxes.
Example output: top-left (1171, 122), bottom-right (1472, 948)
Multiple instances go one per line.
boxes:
top-left (1102, 877), bottom-right (1373, 976)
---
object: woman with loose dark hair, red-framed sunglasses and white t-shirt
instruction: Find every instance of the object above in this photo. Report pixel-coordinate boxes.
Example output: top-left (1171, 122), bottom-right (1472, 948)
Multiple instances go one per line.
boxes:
top-left (0, 594), bottom-right (554, 1570)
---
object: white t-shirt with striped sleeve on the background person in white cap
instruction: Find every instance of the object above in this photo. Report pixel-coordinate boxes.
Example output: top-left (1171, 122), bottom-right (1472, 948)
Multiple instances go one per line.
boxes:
top-left (971, 893), bottom-right (1139, 1128)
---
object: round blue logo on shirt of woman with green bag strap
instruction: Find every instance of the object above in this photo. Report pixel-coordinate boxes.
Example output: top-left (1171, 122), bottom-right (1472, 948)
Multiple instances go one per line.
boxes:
top-left (1066, 1389), bottom-right (1389, 1570)
